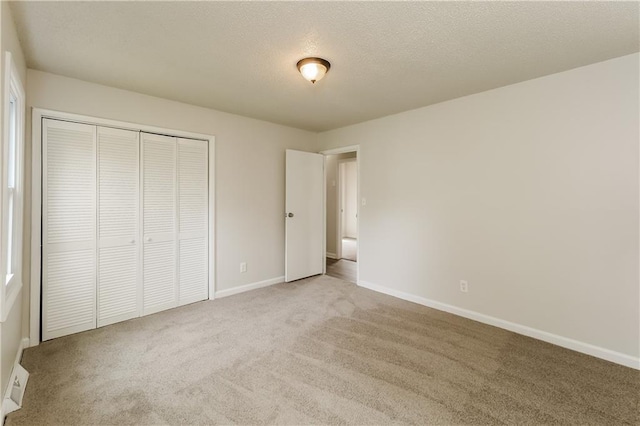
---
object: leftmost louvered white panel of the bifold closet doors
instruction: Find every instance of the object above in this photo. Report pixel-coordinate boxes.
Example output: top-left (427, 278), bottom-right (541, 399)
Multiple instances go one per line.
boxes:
top-left (42, 119), bottom-right (96, 340)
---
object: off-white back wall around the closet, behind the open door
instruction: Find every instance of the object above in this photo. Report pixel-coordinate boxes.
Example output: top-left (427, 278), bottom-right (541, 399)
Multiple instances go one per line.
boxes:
top-left (25, 70), bottom-right (317, 340)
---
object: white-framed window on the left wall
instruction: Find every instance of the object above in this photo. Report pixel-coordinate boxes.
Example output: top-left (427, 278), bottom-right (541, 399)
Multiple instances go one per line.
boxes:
top-left (0, 52), bottom-right (25, 322)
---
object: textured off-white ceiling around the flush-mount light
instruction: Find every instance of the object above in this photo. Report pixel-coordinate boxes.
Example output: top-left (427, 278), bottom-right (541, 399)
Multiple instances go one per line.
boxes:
top-left (11, 2), bottom-right (640, 131)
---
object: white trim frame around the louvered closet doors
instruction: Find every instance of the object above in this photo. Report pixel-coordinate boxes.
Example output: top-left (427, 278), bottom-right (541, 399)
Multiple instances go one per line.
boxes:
top-left (29, 108), bottom-right (216, 347)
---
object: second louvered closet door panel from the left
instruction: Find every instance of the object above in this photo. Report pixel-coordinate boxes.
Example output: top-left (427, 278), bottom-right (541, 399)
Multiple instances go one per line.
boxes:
top-left (97, 127), bottom-right (141, 327)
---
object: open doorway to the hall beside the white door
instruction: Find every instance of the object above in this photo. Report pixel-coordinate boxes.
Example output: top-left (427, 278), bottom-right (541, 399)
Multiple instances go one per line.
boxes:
top-left (323, 147), bottom-right (359, 283)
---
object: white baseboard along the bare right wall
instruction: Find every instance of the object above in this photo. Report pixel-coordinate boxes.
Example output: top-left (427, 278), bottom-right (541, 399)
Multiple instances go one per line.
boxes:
top-left (358, 281), bottom-right (640, 370)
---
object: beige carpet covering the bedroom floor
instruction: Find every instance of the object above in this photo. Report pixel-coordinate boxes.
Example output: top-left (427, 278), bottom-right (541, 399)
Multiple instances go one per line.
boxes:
top-left (7, 276), bottom-right (640, 426)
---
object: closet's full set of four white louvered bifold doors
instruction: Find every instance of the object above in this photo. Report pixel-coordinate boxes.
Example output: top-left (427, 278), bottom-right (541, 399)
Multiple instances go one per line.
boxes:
top-left (42, 119), bottom-right (209, 340)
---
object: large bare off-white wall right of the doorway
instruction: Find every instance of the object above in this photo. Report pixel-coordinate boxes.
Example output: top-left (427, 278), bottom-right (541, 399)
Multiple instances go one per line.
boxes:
top-left (319, 54), bottom-right (640, 362)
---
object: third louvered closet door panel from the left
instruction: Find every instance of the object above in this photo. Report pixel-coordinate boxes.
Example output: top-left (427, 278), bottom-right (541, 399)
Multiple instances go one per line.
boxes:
top-left (140, 133), bottom-right (178, 315)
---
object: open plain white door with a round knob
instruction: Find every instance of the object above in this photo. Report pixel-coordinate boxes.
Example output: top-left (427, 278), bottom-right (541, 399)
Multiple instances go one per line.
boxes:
top-left (285, 149), bottom-right (324, 282)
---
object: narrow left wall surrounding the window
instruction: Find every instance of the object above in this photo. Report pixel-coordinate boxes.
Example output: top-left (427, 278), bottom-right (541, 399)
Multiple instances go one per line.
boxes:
top-left (0, 1), bottom-right (28, 397)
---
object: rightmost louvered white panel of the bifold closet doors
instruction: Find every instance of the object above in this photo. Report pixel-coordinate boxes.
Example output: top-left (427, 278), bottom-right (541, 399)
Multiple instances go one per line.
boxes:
top-left (178, 139), bottom-right (209, 305)
